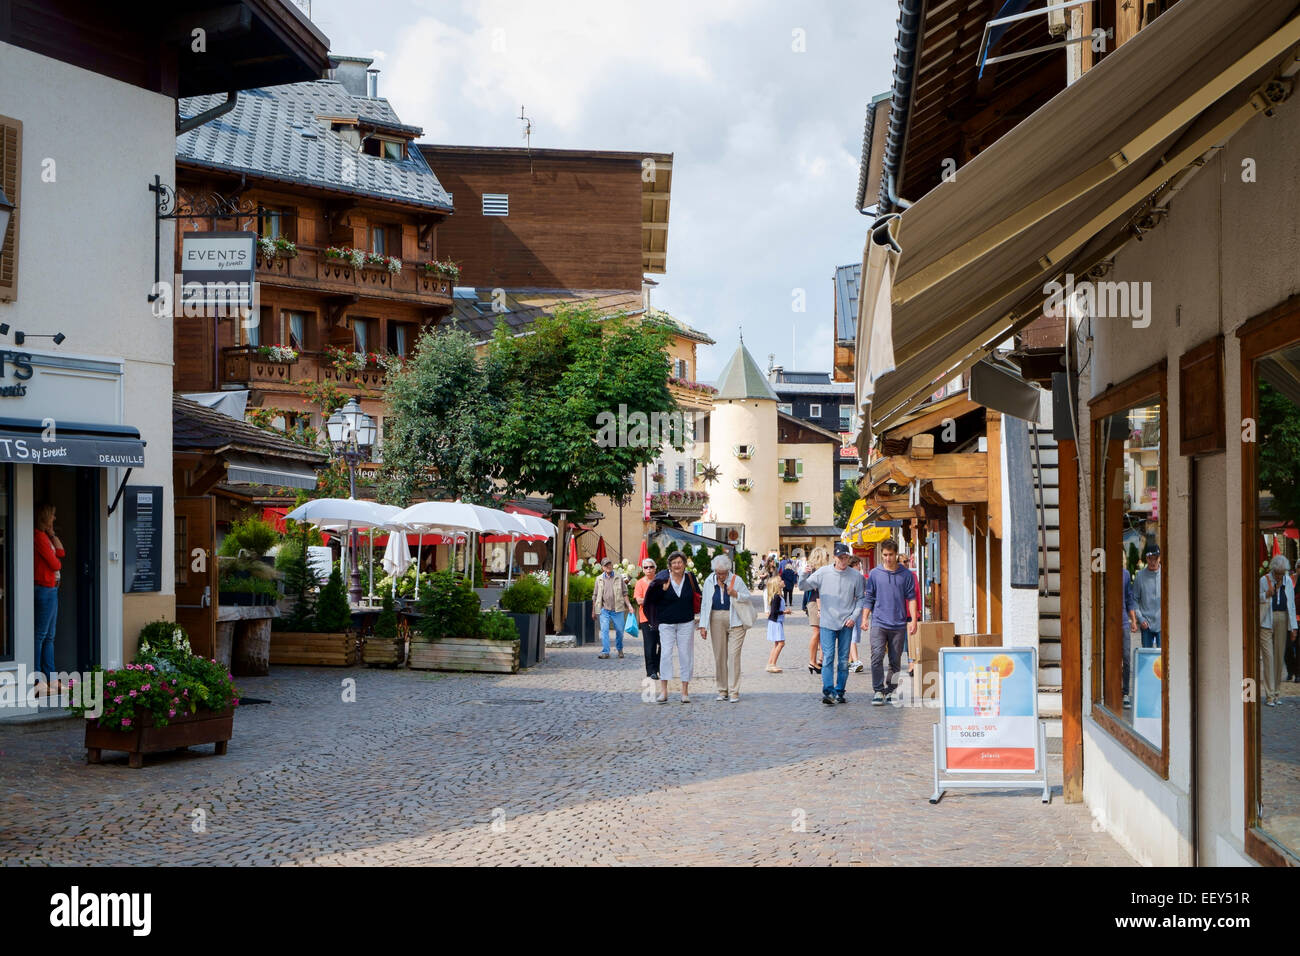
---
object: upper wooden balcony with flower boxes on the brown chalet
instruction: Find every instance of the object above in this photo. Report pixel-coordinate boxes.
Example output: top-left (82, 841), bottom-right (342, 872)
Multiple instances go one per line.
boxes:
top-left (257, 246), bottom-right (454, 307)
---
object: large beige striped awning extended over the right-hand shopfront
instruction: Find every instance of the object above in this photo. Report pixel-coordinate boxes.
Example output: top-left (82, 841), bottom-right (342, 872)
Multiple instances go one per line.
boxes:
top-left (858, 0), bottom-right (1300, 437)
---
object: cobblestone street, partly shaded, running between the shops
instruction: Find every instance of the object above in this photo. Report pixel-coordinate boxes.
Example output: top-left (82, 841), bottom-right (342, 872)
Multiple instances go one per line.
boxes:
top-left (0, 615), bottom-right (1131, 866)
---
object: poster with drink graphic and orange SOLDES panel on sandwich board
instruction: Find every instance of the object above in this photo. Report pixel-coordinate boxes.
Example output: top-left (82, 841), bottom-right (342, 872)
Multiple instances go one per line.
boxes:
top-left (940, 648), bottom-right (1037, 773)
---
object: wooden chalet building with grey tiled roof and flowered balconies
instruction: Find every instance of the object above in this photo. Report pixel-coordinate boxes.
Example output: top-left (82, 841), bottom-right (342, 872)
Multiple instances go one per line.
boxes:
top-left (173, 55), bottom-right (456, 444)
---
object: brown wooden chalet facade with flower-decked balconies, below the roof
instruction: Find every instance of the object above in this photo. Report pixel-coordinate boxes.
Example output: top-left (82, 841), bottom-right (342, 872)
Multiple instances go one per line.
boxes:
top-left (173, 163), bottom-right (452, 425)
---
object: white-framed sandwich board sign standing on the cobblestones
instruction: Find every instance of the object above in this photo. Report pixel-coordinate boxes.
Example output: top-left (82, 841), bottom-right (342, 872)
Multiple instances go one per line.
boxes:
top-left (930, 648), bottom-right (1052, 804)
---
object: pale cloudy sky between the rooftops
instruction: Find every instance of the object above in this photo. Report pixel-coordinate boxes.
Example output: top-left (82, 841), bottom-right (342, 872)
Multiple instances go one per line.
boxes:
top-left (312, 0), bottom-right (898, 380)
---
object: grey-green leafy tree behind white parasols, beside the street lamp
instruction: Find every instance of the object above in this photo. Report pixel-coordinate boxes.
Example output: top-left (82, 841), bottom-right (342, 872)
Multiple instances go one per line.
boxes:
top-left (380, 329), bottom-right (499, 505)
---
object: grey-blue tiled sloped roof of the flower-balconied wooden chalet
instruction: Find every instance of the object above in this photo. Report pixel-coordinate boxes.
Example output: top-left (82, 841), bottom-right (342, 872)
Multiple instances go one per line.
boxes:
top-left (176, 79), bottom-right (451, 212)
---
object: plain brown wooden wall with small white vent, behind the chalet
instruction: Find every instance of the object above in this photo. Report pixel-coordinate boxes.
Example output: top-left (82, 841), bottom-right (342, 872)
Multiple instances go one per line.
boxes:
top-left (420, 144), bottom-right (660, 289)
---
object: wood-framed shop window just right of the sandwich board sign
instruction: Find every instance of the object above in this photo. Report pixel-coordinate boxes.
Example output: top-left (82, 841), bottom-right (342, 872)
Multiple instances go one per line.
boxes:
top-left (1092, 364), bottom-right (1173, 777)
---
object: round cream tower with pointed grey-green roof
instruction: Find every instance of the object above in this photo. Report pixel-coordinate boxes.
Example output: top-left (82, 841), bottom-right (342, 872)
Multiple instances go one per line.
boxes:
top-left (709, 338), bottom-right (780, 554)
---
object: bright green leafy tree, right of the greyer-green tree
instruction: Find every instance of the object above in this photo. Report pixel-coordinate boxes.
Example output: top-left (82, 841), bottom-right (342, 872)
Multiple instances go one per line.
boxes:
top-left (484, 307), bottom-right (683, 515)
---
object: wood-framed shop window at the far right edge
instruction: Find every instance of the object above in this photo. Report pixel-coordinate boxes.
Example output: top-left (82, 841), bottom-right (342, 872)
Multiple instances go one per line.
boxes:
top-left (1242, 321), bottom-right (1300, 864)
